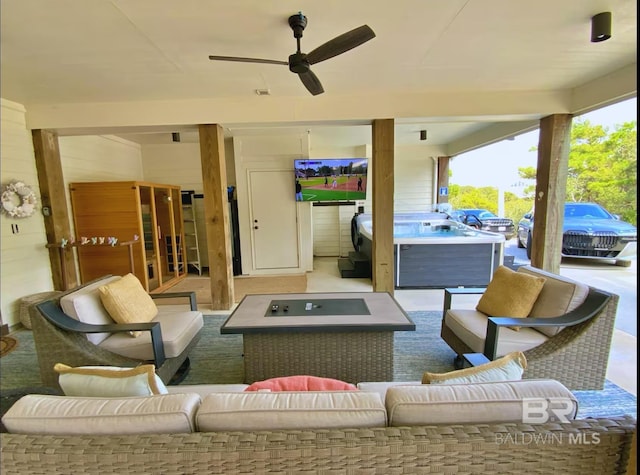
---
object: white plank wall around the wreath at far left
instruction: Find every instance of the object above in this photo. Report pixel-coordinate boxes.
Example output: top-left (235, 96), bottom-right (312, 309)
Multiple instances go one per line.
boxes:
top-left (0, 99), bottom-right (53, 327)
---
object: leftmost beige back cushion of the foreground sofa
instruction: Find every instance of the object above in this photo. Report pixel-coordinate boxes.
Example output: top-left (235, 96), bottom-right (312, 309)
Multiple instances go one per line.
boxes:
top-left (2, 394), bottom-right (201, 435)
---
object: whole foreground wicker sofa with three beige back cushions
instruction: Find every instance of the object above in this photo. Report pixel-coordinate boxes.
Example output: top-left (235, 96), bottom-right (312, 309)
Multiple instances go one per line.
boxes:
top-left (0, 380), bottom-right (636, 475)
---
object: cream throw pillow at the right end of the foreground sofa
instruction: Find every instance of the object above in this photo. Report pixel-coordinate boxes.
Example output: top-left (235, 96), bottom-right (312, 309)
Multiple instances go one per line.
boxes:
top-left (422, 351), bottom-right (527, 384)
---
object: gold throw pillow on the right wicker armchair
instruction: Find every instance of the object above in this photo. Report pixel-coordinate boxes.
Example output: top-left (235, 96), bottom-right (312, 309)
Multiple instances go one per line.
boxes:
top-left (476, 266), bottom-right (545, 331)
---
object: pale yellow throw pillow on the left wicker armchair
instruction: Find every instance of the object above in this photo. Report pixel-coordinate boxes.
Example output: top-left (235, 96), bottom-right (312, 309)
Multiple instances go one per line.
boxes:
top-left (98, 273), bottom-right (158, 337)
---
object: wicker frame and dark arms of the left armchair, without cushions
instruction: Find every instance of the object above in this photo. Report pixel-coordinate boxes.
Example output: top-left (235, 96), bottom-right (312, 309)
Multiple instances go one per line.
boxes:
top-left (29, 281), bottom-right (201, 389)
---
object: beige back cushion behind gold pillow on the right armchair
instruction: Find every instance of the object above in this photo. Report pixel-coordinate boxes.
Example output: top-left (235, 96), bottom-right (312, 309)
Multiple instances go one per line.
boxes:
top-left (518, 266), bottom-right (589, 336)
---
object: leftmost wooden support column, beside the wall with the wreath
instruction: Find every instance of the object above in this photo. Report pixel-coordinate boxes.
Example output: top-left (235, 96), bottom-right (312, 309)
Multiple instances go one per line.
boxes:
top-left (31, 130), bottom-right (80, 290)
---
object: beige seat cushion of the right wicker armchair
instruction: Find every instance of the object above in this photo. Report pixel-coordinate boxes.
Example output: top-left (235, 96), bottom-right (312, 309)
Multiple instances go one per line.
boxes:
top-left (444, 309), bottom-right (549, 356)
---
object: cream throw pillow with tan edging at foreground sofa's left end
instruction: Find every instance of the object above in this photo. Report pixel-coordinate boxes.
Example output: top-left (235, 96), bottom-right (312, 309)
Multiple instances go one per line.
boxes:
top-left (53, 363), bottom-right (169, 397)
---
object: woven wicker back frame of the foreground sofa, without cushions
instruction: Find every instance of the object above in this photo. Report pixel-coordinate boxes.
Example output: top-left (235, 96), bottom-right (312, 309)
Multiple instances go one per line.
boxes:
top-left (0, 416), bottom-right (636, 475)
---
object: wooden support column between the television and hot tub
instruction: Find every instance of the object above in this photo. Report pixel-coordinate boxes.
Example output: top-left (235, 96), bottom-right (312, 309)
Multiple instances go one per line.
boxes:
top-left (371, 119), bottom-right (395, 295)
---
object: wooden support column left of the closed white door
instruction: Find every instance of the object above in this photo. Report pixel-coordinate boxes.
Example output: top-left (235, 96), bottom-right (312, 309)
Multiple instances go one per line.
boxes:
top-left (199, 124), bottom-right (234, 310)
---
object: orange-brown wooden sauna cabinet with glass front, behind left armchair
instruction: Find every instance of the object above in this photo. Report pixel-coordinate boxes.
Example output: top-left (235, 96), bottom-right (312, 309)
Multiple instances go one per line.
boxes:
top-left (69, 181), bottom-right (186, 292)
